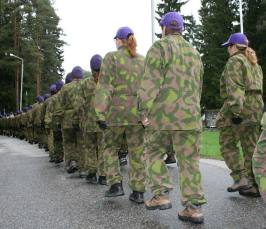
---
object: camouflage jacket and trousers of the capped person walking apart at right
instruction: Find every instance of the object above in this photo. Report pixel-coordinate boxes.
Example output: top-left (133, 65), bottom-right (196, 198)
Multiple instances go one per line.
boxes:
top-left (216, 51), bottom-right (264, 187)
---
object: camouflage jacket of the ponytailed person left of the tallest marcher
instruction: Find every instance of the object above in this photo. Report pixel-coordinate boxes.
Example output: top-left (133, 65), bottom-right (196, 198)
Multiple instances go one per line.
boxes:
top-left (95, 46), bottom-right (144, 126)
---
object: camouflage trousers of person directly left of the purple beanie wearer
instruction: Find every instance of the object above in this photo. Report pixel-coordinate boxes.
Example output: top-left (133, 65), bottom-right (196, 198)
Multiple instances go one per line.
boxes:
top-left (62, 128), bottom-right (85, 171)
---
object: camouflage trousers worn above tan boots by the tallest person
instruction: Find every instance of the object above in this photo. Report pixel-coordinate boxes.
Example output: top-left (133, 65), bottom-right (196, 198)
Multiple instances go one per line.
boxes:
top-left (144, 130), bottom-right (206, 206)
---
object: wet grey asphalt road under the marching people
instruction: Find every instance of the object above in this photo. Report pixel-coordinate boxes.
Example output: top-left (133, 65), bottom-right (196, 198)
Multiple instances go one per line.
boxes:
top-left (0, 136), bottom-right (266, 229)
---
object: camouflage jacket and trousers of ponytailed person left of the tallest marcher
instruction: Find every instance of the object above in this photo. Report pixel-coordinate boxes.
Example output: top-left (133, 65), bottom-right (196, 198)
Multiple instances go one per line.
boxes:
top-left (95, 45), bottom-right (146, 192)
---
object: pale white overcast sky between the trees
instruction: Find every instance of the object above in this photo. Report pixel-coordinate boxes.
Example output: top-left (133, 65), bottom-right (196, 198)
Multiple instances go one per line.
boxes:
top-left (54, 0), bottom-right (200, 77)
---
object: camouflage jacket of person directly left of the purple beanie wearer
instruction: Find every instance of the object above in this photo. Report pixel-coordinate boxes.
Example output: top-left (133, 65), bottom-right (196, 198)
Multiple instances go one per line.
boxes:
top-left (55, 79), bottom-right (81, 129)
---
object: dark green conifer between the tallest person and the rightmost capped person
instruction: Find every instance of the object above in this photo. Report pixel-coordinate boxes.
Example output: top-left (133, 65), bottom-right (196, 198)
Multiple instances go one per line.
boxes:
top-left (197, 0), bottom-right (239, 109)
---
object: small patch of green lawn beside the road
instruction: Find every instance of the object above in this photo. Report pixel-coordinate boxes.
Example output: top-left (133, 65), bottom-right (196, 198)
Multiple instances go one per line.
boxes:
top-left (200, 132), bottom-right (223, 160)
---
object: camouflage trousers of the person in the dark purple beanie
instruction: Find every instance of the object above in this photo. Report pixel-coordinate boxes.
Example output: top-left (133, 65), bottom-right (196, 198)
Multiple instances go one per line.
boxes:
top-left (84, 132), bottom-right (105, 176)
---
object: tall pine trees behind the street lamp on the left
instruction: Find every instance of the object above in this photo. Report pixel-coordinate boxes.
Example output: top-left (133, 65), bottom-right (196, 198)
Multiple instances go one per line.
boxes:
top-left (0, 0), bottom-right (65, 112)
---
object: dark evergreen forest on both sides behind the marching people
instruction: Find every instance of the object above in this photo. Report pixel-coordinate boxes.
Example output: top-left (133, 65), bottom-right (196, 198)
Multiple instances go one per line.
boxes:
top-left (0, 0), bottom-right (266, 114)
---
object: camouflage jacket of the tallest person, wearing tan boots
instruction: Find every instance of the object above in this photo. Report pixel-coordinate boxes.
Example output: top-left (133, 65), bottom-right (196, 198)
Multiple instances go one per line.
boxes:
top-left (138, 33), bottom-right (203, 131)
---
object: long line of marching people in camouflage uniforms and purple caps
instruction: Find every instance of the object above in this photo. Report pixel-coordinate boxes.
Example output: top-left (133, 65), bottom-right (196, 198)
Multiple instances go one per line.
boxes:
top-left (0, 12), bottom-right (266, 223)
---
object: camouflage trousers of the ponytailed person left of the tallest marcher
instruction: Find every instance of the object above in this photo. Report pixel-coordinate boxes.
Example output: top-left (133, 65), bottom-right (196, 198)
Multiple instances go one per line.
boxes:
top-left (103, 125), bottom-right (146, 192)
